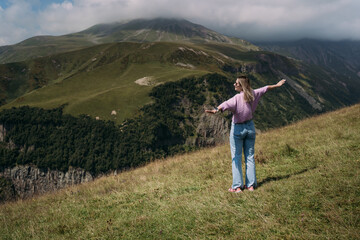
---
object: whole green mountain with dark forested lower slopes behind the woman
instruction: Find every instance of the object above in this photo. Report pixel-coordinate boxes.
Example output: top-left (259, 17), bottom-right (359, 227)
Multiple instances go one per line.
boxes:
top-left (0, 19), bottom-right (360, 202)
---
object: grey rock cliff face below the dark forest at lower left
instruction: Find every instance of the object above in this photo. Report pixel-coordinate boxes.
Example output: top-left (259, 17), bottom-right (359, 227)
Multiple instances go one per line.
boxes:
top-left (0, 165), bottom-right (93, 202)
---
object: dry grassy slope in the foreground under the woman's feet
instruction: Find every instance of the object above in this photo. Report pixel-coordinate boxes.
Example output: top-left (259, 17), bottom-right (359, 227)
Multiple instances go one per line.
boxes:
top-left (0, 105), bottom-right (360, 239)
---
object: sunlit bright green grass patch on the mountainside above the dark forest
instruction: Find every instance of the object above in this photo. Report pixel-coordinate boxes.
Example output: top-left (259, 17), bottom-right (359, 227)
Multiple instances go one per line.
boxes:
top-left (5, 62), bottom-right (208, 123)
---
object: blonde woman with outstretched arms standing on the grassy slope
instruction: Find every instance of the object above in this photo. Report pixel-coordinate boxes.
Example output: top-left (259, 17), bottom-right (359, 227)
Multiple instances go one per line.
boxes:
top-left (205, 76), bottom-right (286, 193)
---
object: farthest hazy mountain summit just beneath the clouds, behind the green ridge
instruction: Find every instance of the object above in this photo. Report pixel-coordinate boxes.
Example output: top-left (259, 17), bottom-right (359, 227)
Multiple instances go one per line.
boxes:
top-left (0, 18), bottom-right (259, 63)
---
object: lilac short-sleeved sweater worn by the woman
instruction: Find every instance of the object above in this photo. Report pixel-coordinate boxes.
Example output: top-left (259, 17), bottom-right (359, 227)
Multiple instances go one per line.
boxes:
top-left (219, 86), bottom-right (268, 123)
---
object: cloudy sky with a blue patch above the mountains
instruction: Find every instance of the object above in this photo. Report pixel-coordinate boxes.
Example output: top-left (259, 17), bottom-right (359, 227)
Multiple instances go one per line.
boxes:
top-left (0, 0), bottom-right (360, 46)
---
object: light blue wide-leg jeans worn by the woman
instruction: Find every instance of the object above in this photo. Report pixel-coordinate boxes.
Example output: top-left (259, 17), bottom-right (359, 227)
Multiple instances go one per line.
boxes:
top-left (230, 120), bottom-right (257, 189)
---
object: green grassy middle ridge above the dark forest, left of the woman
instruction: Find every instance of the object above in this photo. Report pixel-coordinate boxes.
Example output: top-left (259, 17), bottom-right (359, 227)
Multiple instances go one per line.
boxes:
top-left (0, 43), bottom-right (221, 123)
